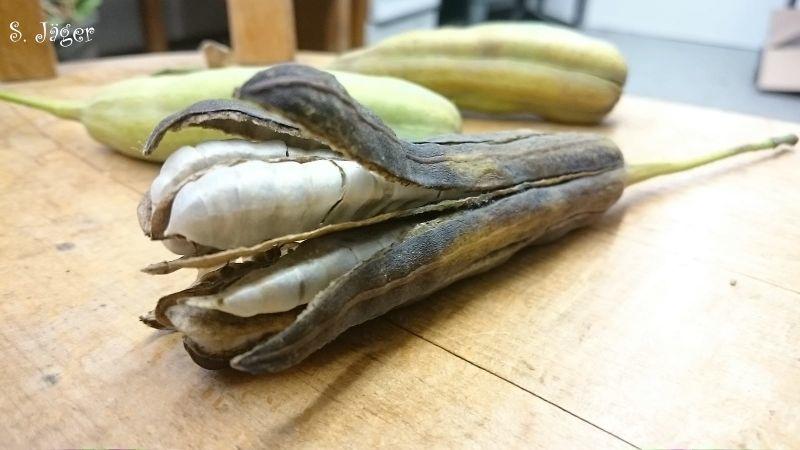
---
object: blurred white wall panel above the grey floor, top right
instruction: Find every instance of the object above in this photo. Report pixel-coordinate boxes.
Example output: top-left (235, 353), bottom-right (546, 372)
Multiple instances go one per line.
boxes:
top-left (580, 0), bottom-right (788, 49)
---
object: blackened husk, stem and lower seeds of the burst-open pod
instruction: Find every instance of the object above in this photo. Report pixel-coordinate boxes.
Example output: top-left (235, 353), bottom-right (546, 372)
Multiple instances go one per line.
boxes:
top-left (143, 65), bottom-right (797, 373)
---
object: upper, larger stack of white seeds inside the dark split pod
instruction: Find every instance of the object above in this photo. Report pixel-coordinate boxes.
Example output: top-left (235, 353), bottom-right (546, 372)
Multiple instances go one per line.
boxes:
top-left (157, 141), bottom-right (463, 254)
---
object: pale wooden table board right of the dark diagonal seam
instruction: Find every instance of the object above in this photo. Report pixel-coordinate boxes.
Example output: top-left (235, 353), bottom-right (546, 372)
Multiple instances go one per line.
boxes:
top-left (389, 107), bottom-right (800, 448)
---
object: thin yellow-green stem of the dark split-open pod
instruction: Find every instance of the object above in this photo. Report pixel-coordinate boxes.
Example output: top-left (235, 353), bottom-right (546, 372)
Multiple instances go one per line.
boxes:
top-left (625, 134), bottom-right (797, 186)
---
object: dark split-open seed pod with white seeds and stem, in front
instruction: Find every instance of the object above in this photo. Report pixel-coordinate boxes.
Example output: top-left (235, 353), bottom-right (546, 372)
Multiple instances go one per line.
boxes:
top-left (139, 65), bottom-right (797, 373)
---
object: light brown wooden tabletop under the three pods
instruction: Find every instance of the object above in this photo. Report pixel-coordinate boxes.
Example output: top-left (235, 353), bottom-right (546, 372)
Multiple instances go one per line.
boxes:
top-left (0, 54), bottom-right (800, 448)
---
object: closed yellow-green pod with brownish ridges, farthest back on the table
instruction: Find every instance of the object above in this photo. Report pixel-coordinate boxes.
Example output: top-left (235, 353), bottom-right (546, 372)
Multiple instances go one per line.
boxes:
top-left (331, 23), bottom-right (627, 123)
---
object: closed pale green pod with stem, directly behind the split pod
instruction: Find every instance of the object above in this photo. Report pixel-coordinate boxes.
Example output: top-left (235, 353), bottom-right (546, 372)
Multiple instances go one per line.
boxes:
top-left (0, 67), bottom-right (461, 161)
